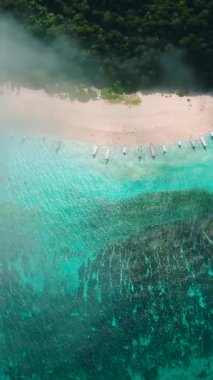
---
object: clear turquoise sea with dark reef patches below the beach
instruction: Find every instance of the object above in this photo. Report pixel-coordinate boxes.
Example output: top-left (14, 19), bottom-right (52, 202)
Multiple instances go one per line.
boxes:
top-left (0, 133), bottom-right (213, 380)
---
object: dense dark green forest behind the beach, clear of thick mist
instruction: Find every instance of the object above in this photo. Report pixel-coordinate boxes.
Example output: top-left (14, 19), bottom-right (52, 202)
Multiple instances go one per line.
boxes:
top-left (0, 0), bottom-right (213, 90)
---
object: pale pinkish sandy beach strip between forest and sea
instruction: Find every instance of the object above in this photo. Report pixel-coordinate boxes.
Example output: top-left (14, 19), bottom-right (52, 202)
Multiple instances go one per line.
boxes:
top-left (0, 87), bottom-right (213, 146)
